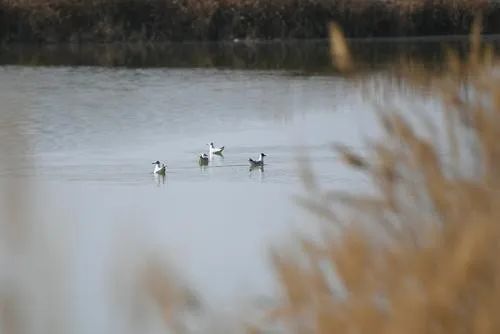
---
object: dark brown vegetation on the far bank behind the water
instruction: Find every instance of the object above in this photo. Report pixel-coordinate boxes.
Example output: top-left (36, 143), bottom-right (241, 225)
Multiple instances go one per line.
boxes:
top-left (0, 0), bottom-right (500, 43)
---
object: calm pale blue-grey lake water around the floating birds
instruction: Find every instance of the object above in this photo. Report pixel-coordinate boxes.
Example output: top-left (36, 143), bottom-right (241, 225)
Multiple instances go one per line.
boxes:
top-left (0, 41), bottom-right (492, 333)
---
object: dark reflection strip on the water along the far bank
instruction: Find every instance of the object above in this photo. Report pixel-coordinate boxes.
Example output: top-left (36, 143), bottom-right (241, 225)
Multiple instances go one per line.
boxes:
top-left (0, 36), bottom-right (500, 75)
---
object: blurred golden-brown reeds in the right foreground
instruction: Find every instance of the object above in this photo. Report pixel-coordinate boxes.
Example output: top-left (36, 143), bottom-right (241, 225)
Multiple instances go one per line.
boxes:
top-left (260, 22), bottom-right (500, 333)
